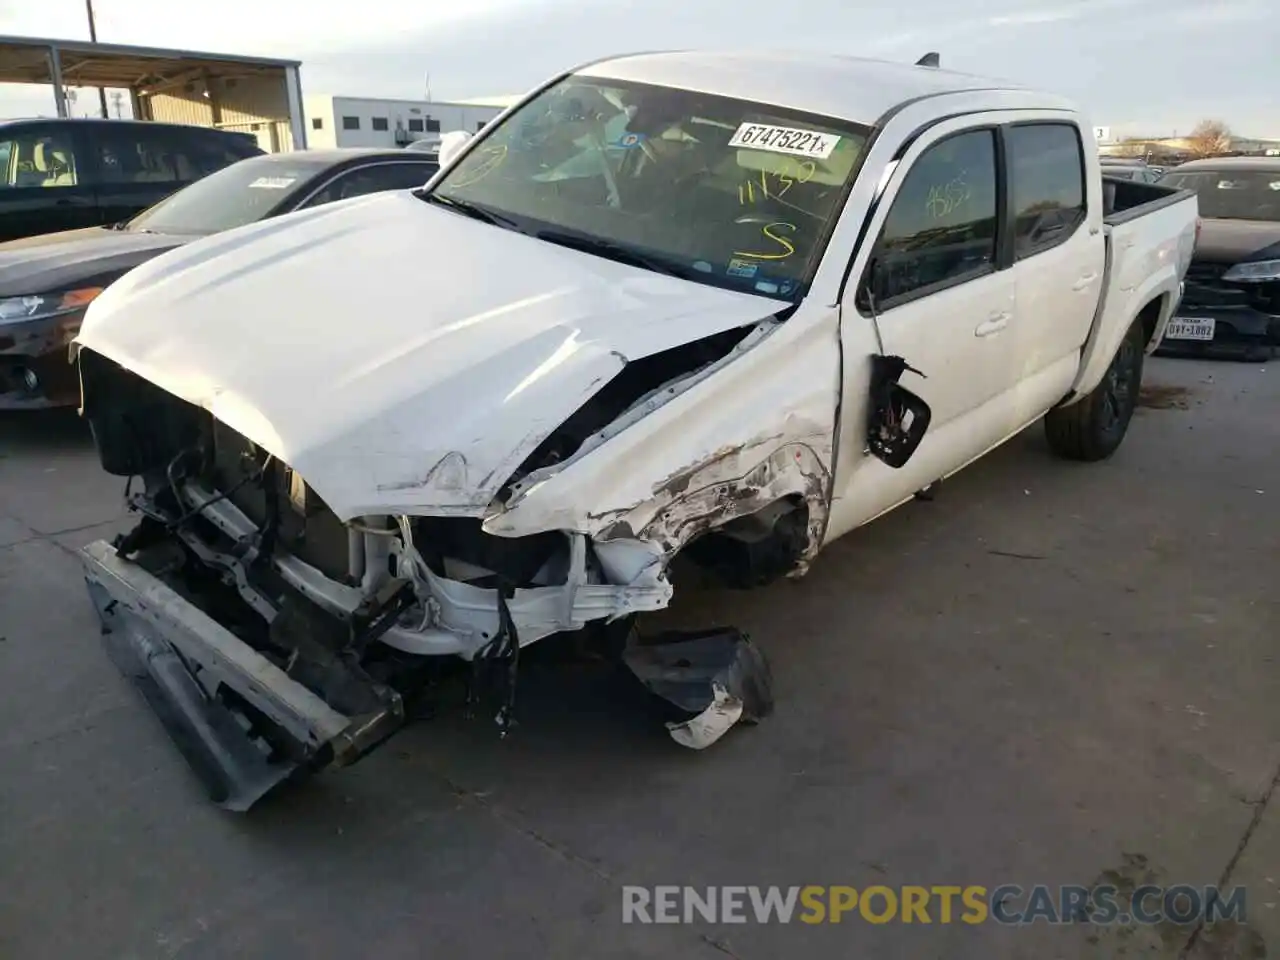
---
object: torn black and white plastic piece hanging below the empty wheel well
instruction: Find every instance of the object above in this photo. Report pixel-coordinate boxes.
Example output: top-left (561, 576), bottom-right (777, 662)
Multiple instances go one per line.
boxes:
top-left (622, 627), bottom-right (773, 750)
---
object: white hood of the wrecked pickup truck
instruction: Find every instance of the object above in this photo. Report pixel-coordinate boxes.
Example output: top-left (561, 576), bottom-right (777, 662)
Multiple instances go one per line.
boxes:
top-left (77, 192), bottom-right (786, 520)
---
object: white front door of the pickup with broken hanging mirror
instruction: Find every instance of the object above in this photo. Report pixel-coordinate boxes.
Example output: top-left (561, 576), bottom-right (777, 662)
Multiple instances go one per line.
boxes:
top-left (828, 116), bottom-right (1019, 539)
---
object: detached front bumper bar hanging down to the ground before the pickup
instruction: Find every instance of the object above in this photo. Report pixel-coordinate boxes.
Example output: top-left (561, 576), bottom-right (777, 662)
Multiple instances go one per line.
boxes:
top-left (82, 540), bottom-right (403, 812)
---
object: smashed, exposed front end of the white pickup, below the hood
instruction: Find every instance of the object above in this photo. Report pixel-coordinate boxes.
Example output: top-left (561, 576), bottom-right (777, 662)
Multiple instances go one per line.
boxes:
top-left (78, 320), bottom-right (798, 810)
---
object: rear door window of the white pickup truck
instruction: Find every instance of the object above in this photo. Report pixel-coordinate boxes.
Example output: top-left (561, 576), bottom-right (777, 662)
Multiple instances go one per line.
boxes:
top-left (1005, 123), bottom-right (1085, 260)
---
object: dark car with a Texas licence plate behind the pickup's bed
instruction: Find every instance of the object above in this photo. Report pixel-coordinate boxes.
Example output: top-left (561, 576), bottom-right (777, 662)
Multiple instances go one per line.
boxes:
top-left (1160, 157), bottom-right (1280, 361)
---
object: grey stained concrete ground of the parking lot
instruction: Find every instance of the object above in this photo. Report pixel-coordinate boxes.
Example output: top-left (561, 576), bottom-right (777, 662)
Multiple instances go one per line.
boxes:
top-left (0, 360), bottom-right (1280, 960)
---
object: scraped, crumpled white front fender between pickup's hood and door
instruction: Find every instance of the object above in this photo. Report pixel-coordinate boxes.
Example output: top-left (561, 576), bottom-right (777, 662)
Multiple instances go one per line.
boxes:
top-left (484, 310), bottom-right (840, 561)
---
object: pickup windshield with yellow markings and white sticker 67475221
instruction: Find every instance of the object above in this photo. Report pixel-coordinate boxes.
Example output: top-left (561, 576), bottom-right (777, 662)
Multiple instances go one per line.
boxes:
top-left (428, 76), bottom-right (869, 300)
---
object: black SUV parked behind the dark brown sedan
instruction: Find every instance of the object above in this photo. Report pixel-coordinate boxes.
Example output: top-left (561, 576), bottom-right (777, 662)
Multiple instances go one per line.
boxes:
top-left (0, 119), bottom-right (264, 241)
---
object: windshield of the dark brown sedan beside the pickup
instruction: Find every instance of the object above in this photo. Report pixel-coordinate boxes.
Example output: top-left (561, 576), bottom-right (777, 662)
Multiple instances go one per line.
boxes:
top-left (127, 157), bottom-right (326, 234)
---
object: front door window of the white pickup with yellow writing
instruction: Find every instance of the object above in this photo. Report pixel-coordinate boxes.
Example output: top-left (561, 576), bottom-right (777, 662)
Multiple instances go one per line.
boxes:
top-left (874, 129), bottom-right (998, 308)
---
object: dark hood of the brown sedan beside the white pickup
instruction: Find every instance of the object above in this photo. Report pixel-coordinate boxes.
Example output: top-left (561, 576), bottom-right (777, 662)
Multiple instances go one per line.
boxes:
top-left (0, 227), bottom-right (189, 297)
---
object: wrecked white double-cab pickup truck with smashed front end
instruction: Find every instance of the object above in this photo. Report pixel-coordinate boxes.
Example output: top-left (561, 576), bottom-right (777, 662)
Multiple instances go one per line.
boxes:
top-left (78, 52), bottom-right (1197, 809)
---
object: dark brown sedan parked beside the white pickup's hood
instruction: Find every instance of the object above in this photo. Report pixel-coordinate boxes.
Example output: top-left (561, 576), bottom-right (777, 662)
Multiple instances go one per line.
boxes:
top-left (0, 150), bottom-right (438, 410)
